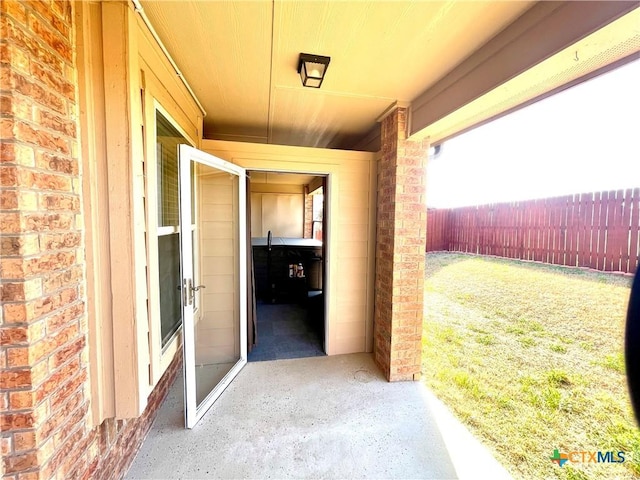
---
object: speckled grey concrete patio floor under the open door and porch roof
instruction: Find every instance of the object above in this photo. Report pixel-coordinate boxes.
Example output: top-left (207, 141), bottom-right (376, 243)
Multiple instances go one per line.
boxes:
top-left (125, 354), bottom-right (510, 479)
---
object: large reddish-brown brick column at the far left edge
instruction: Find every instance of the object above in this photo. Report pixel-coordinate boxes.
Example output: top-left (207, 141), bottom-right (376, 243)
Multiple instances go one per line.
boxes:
top-left (0, 0), bottom-right (95, 479)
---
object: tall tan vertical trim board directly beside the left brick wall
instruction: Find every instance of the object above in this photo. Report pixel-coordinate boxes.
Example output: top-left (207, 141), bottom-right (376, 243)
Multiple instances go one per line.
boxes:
top-left (76, 2), bottom-right (115, 420)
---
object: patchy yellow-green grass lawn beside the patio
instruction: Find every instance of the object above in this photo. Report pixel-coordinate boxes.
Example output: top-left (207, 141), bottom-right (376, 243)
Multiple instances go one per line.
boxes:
top-left (423, 253), bottom-right (640, 479)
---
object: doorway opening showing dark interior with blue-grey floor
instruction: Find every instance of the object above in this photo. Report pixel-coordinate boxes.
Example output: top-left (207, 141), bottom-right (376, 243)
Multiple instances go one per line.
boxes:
top-left (247, 171), bottom-right (327, 362)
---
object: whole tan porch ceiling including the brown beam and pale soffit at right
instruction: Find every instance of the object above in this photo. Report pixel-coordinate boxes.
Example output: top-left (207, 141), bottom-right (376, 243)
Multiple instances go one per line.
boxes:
top-left (140, 0), bottom-right (640, 150)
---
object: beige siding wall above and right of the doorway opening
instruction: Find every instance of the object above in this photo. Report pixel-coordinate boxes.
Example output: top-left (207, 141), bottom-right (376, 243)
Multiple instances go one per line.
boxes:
top-left (202, 140), bottom-right (376, 355)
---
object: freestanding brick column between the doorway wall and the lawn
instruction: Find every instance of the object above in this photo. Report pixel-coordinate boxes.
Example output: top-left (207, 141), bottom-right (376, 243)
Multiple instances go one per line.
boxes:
top-left (374, 108), bottom-right (428, 381)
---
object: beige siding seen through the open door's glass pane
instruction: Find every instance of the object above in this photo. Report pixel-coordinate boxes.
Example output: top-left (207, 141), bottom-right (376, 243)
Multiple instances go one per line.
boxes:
top-left (196, 166), bottom-right (240, 365)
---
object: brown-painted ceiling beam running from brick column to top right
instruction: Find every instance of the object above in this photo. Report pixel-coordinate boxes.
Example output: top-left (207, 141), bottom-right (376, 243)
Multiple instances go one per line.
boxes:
top-left (410, 1), bottom-right (638, 140)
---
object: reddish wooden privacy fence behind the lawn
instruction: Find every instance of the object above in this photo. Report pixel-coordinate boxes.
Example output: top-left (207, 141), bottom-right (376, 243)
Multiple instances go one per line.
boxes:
top-left (426, 188), bottom-right (640, 273)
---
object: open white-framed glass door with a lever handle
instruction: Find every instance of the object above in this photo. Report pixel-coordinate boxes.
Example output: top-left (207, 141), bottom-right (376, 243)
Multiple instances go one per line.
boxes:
top-left (179, 145), bottom-right (247, 428)
